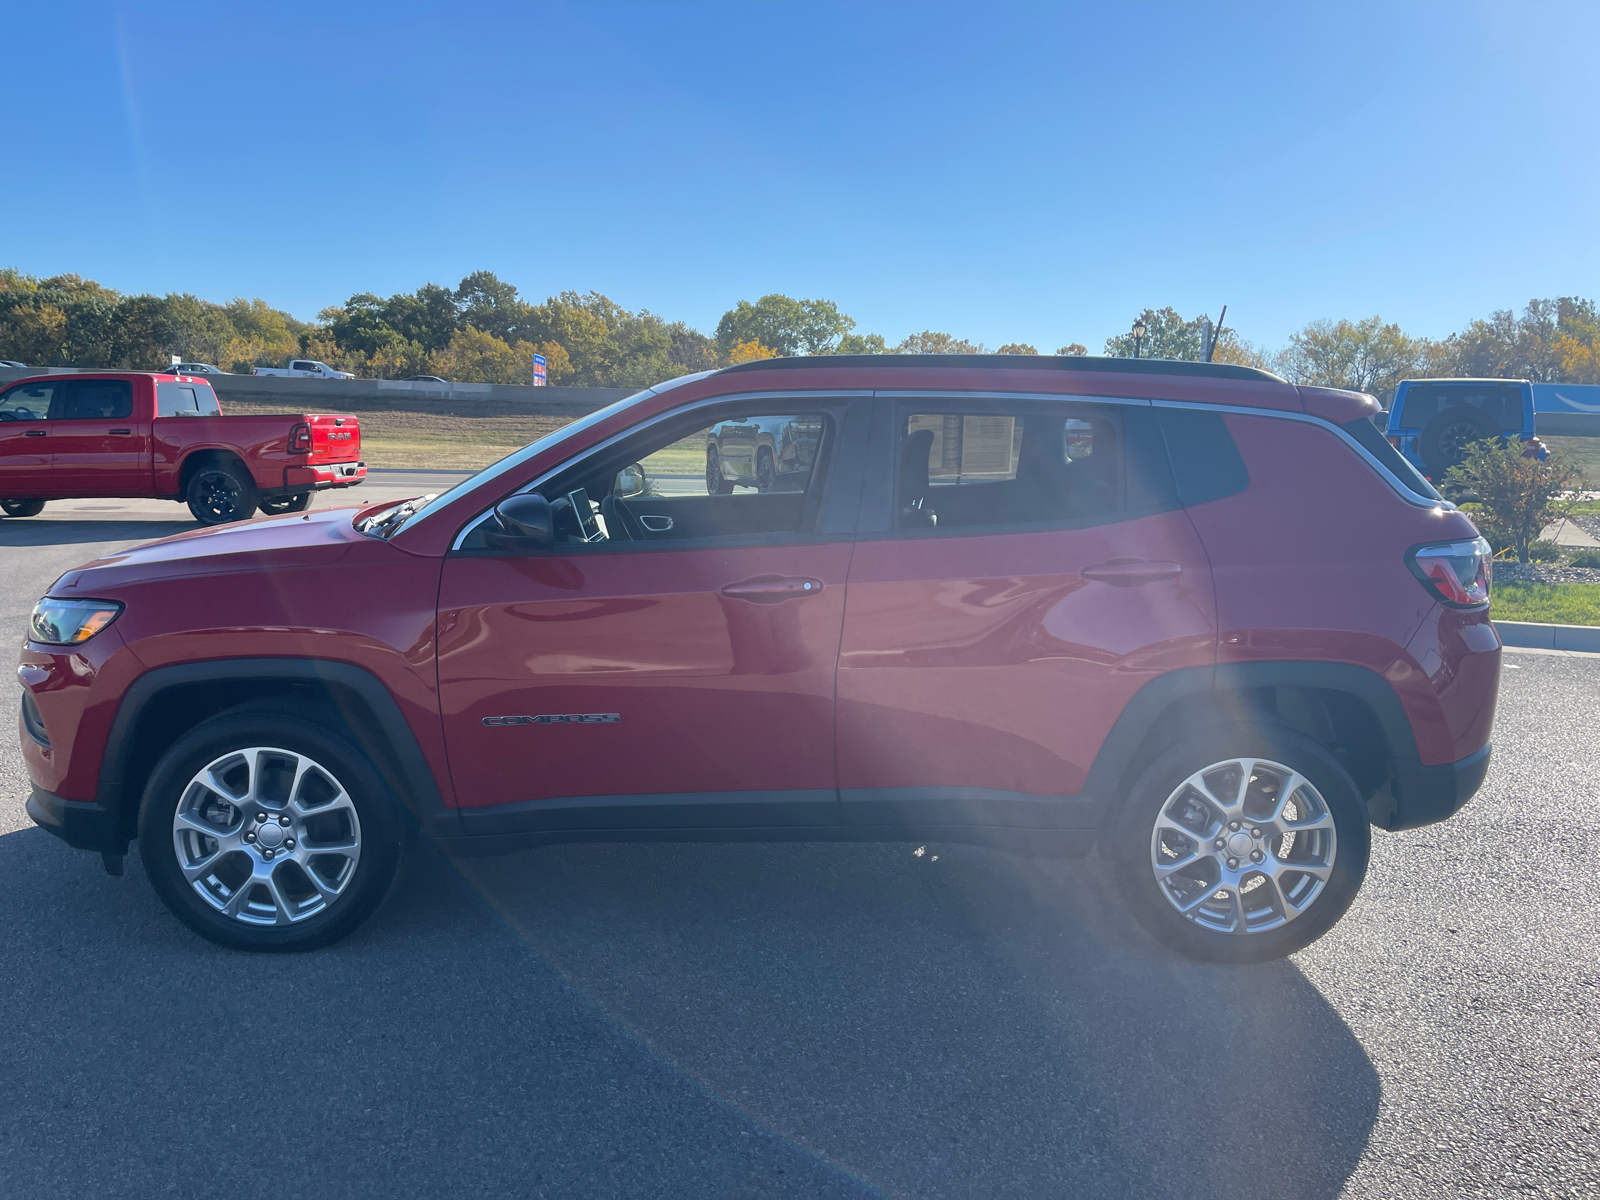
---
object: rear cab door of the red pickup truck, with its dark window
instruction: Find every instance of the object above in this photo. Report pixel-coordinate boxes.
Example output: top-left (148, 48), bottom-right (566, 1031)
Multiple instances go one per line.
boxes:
top-left (50, 379), bottom-right (150, 496)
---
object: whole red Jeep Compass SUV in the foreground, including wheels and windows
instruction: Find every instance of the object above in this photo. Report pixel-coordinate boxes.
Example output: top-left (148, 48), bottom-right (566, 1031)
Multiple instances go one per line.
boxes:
top-left (18, 355), bottom-right (1499, 962)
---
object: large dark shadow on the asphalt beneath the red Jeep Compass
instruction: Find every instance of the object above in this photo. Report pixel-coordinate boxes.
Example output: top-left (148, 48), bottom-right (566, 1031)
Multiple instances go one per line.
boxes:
top-left (0, 830), bottom-right (1379, 1197)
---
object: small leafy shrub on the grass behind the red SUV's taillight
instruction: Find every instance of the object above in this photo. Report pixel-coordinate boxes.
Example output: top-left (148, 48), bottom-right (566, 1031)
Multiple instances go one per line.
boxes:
top-left (1445, 438), bottom-right (1589, 563)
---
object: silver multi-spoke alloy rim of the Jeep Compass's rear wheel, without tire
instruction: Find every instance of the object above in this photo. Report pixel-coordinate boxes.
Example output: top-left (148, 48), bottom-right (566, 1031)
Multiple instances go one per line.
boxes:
top-left (1150, 758), bottom-right (1338, 934)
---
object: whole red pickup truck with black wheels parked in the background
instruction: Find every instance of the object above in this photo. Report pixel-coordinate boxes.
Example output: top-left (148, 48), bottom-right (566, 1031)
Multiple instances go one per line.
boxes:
top-left (0, 371), bottom-right (366, 525)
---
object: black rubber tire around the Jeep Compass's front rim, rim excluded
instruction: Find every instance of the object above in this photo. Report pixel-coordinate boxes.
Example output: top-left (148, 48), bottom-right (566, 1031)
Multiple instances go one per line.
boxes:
top-left (139, 712), bottom-right (403, 950)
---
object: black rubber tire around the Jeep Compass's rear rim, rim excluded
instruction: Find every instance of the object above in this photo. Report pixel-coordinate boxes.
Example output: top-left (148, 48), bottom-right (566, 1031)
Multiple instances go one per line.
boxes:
top-left (1107, 725), bottom-right (1371, 963)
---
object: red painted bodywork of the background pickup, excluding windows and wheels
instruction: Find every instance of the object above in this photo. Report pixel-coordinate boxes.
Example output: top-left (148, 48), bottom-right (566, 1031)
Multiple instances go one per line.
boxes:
top-left (0, 371), bottom-right (366, 499)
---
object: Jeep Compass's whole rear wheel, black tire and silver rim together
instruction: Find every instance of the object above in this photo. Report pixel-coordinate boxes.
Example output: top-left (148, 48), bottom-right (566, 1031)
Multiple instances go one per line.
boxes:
top-left (1109, 725), bottom-right (1371, 963)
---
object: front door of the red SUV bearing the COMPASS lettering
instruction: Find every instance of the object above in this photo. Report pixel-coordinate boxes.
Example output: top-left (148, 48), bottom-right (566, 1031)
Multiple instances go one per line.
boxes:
top-left (438, 397), bottom-right (867, 832)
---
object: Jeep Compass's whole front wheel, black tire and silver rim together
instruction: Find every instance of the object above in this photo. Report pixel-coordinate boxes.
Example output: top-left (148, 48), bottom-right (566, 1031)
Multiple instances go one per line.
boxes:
top-left (139, 709), bottom-right (403, 950)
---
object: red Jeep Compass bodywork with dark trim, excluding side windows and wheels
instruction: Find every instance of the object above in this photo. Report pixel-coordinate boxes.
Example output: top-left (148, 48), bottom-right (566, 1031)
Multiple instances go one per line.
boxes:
top-left (21, 358), bottom-right (1499, 870)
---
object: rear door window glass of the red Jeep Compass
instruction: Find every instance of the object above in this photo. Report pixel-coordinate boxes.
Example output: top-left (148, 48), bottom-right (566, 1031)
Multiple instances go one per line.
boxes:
top-left (894, 403), bottom-right (1174, 530)
